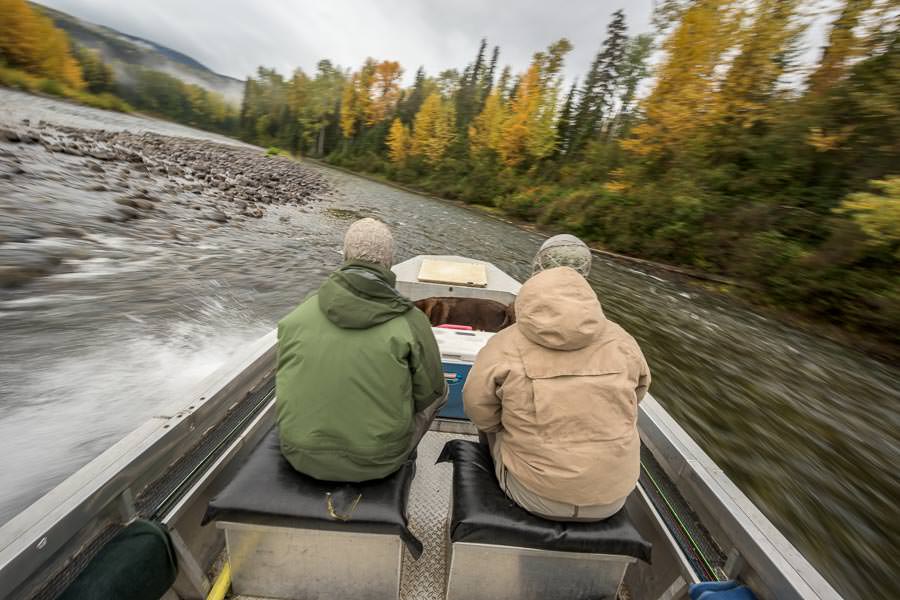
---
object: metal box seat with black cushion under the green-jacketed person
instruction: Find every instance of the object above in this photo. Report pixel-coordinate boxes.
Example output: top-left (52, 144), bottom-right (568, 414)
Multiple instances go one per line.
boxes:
top-left (203, 428), bottom-right (422, 598)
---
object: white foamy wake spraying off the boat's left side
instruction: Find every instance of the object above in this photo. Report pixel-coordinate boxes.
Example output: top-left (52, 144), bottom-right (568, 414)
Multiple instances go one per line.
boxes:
top-left (0, 319), bottom-right (269, 524)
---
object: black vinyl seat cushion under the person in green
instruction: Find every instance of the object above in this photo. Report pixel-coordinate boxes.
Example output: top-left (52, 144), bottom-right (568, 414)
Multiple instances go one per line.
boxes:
top-left (203, 428), bottom-right (422, 559)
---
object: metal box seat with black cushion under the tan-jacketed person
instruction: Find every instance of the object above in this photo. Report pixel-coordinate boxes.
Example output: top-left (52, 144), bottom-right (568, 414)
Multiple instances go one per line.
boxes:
top-left (438, 440), bottom-right (651, 600)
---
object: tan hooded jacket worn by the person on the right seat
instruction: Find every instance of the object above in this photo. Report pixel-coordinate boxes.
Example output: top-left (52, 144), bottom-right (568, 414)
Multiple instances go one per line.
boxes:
top-left (463, 267), bottom-right (650, 506)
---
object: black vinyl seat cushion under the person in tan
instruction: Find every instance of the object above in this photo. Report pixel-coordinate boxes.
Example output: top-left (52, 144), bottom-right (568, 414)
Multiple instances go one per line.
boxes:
top-left (438, 440), bottom-right (651, 563)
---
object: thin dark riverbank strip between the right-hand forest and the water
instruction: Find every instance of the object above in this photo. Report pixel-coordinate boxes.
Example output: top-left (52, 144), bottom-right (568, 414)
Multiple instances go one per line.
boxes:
top-left (312, 157), bottom-right (900, 361)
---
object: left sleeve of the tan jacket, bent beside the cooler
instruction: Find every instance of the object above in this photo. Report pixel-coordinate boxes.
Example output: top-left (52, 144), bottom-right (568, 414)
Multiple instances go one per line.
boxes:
top-left (463, 334), bottom-right (509, 433)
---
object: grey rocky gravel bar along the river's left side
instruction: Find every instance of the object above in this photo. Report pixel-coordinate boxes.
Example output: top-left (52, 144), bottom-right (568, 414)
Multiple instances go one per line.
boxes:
top-left (0, 119), bottom-right (332, 289)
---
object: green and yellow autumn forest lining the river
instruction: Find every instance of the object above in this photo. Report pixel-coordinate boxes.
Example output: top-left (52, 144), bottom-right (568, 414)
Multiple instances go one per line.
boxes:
top-left (0, 0), bottom-right (900, 351)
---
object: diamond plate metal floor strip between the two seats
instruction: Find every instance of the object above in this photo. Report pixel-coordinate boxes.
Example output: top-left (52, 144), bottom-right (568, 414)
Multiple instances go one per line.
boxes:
top-left (400, 431), bottom-right (475, 600)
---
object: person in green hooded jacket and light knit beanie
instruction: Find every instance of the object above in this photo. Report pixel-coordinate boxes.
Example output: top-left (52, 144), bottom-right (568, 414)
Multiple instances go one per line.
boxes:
top-left (276, 219), bottom-right (447, 482)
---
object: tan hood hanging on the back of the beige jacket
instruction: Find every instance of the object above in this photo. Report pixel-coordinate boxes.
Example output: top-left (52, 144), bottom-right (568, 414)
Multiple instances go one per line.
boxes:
top-left (516, 267), bottom-right (607, 350)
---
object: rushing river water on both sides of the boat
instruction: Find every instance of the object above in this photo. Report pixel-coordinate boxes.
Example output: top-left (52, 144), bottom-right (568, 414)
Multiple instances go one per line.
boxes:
top-left (0, 90), bottom-right (900, 598)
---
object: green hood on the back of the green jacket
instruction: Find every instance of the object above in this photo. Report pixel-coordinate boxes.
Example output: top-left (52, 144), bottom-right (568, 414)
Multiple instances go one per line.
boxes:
top-left (318, 261), bottom-right (413, 329)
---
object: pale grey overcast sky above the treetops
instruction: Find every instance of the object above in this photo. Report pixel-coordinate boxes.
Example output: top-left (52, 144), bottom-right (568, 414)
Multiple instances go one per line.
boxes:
top-left (39, 0), bottom-right (653, 83)
